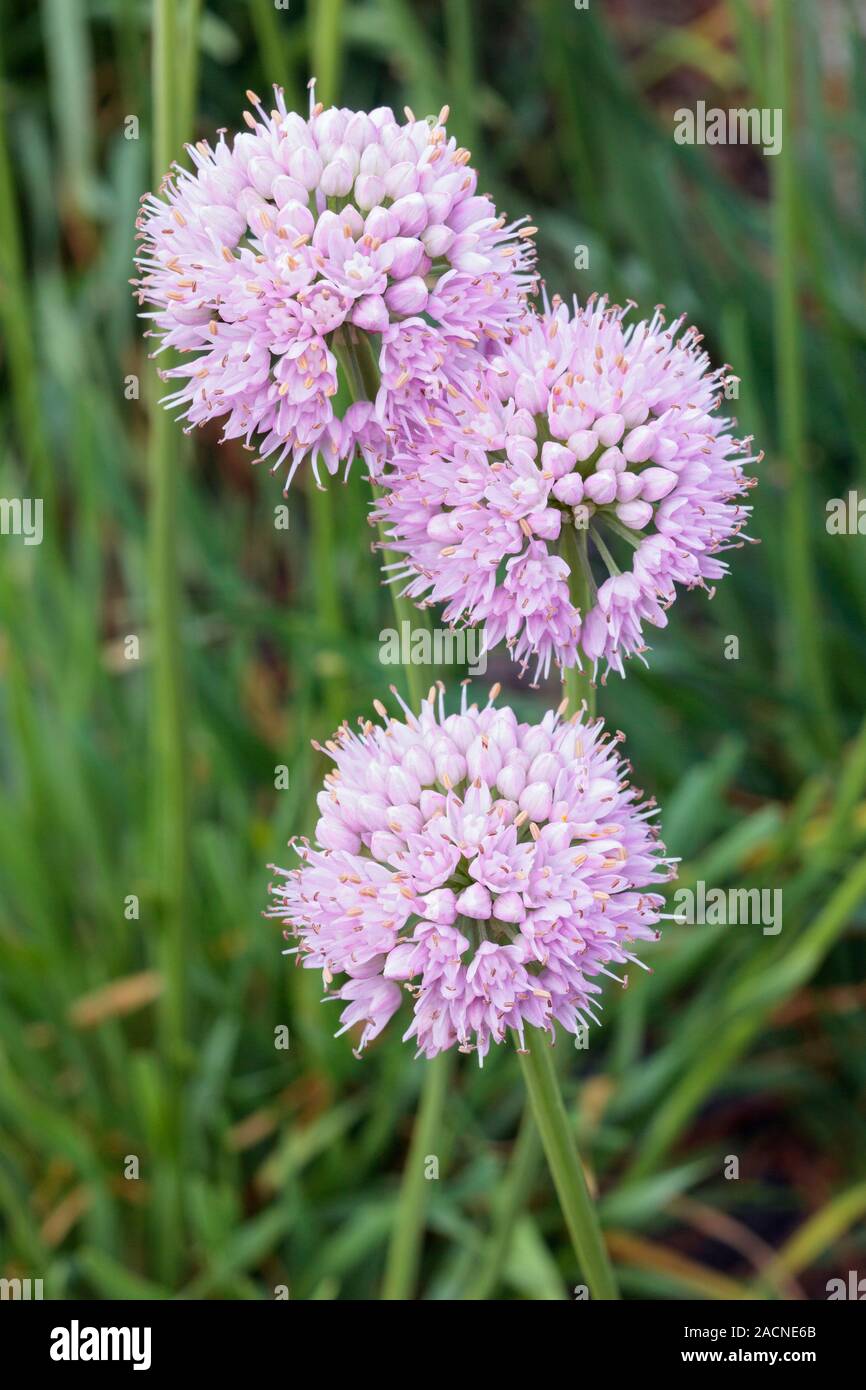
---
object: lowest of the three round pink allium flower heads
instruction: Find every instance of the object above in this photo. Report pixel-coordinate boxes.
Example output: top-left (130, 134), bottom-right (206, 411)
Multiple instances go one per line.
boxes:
top-left (268, 687), bottom-right (673, 1061)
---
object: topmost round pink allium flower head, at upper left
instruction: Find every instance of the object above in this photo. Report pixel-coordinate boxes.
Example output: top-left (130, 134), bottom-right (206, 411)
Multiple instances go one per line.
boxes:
top-left (135, 88), bottom-right (534, 487)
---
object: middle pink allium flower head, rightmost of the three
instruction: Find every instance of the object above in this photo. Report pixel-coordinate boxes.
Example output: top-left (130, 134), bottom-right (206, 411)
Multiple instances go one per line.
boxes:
top-left (378, 296), bottom-right (756, 676)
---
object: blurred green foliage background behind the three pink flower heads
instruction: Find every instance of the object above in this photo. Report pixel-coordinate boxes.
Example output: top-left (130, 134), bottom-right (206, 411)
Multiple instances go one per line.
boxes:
top-left (0, 0), bottom-right (866, 1298)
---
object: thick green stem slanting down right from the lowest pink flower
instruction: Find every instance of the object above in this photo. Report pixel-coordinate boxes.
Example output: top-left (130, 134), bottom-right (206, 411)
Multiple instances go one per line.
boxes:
top-left (518, 1033), bottom-right (619, 1300)
